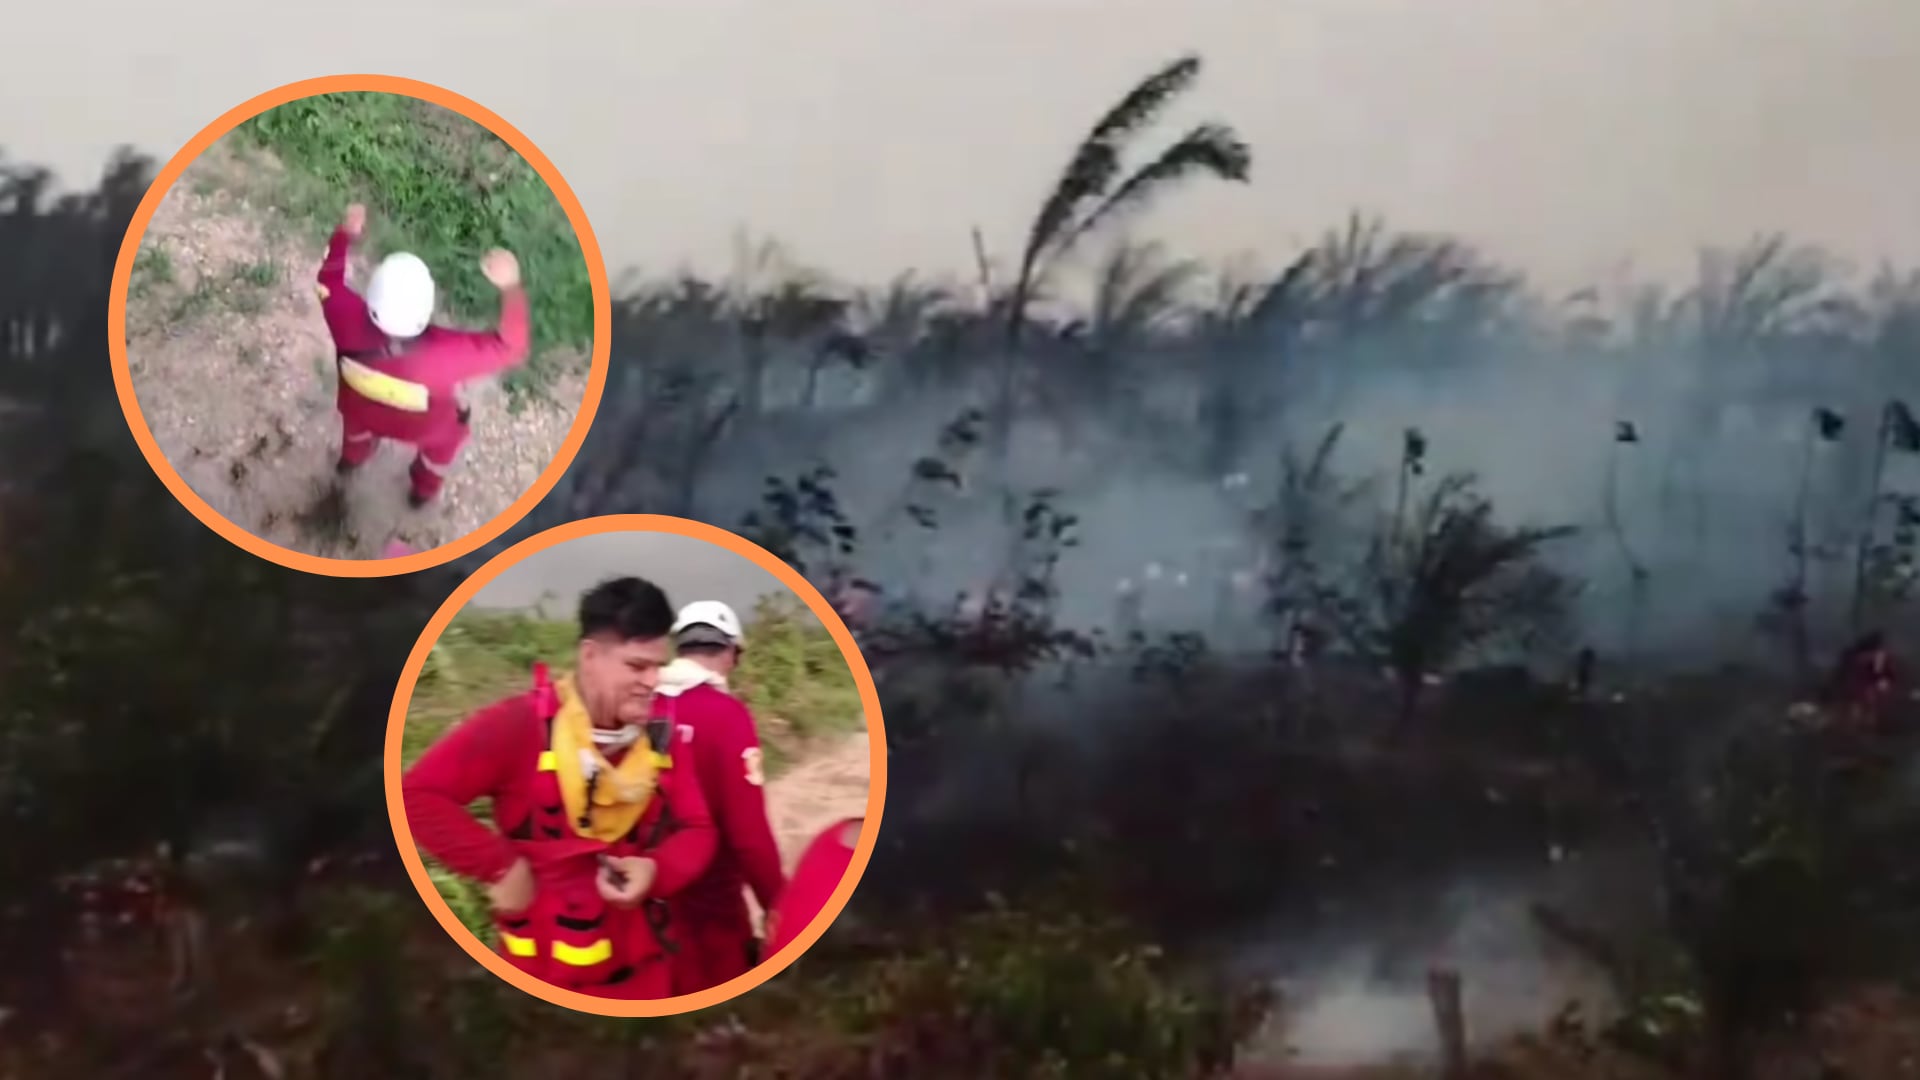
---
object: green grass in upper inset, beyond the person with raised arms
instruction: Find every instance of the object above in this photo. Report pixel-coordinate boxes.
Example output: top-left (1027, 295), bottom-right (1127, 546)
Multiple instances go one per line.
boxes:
top-left (234, 92), bottom-right (593, 398)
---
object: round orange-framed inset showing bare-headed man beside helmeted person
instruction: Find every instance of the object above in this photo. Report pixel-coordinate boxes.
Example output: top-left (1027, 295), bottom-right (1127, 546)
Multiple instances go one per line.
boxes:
top-left (386, 515), bottom-right (887, 1017)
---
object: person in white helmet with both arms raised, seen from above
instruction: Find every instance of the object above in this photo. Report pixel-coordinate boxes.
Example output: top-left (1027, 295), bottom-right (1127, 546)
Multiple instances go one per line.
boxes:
top-left (319, 204), bottom-right (530, 507)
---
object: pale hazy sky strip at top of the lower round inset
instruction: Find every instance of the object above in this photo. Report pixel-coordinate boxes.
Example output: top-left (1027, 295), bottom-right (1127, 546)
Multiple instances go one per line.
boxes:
top-left (472, 532), bottom-right (791, 619)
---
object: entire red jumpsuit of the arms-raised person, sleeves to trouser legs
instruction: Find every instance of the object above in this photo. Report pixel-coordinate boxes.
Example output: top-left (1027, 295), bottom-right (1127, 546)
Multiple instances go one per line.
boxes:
top-left (319, 229), bottom-right (530, 502)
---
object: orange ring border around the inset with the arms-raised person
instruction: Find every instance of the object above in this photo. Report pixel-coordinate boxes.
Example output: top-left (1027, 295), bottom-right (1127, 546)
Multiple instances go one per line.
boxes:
top-left (108, 75), bottom-right (612, 578)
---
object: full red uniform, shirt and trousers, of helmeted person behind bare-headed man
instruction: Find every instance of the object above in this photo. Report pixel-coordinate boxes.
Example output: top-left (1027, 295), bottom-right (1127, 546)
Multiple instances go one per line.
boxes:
top-left (670, 684), bottom-right (785, 994)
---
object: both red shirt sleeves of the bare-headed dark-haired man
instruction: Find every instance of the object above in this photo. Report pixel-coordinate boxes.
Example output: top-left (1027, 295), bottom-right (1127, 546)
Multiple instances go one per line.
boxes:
top-left (401, 692), bottom-right (716, 897)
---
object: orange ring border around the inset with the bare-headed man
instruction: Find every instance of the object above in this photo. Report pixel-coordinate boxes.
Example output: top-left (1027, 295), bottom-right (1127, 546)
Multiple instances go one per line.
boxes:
top-left (384, 513), bottom-right (887, 1017)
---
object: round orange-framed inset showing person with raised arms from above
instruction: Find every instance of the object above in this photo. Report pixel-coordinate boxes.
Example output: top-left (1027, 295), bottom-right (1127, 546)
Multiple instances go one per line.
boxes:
top-left (109, 77), bottom-right (609, 577)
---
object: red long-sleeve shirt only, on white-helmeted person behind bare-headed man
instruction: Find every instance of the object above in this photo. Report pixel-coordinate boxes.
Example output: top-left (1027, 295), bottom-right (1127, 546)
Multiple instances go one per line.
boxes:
top-left (672, 686), bottom-right (785, 926)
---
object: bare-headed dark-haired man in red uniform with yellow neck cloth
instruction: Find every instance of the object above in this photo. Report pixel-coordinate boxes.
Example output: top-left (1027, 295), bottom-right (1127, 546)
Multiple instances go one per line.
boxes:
top-left (401, 578), bottom-right (714, 999)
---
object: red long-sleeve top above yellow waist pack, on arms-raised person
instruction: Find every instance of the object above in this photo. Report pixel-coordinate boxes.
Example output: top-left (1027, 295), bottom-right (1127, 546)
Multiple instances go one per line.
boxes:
top-left (319, 229), bottom-right (532, 390)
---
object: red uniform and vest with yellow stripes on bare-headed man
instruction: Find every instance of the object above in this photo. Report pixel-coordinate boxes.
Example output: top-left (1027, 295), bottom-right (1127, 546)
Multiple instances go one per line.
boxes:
top-left (401, 672), bottom-right (714, 999)
